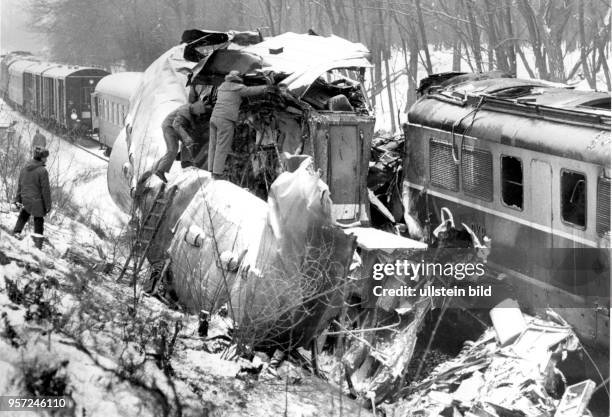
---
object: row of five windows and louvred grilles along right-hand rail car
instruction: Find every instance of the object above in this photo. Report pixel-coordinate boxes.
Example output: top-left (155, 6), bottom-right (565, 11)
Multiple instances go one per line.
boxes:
top-left (429, 139), bottom-right (610, 235)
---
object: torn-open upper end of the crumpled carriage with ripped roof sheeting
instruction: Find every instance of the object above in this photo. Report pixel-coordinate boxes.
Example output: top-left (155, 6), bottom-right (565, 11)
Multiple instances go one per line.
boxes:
top-left (183, 31), bottom-right (375, 225)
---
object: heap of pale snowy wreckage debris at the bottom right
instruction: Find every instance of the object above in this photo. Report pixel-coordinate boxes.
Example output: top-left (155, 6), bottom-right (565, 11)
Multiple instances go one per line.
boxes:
top-left (382, 308), bottom-right (595, 417)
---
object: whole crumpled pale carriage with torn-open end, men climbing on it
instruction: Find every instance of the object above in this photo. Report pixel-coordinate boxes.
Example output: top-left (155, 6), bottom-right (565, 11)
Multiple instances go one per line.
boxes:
top-left (108, 30), bottom-right (374, 345)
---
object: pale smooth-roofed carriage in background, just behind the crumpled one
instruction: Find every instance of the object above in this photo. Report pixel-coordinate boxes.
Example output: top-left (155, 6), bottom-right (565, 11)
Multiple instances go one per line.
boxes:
top-left (91, 72), bottom-right (143, 156)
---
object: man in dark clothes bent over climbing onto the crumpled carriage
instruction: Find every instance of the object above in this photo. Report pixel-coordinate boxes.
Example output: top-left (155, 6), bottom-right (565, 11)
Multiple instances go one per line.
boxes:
top-left (155, 101), bottom-right (207, 182)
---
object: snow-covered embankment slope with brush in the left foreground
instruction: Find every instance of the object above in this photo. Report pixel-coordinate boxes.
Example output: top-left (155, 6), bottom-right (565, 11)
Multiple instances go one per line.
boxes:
top-left (0, 208), bottom-right (371, 417)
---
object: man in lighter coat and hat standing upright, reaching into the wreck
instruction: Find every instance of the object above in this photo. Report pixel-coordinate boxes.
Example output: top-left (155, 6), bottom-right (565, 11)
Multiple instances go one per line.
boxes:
top-left (208, 71), bottom-right (269, 178)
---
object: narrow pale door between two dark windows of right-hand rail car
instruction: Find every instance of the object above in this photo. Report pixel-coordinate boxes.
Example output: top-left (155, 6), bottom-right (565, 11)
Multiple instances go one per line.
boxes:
top-left (529, 159), bottom-right (553, 282)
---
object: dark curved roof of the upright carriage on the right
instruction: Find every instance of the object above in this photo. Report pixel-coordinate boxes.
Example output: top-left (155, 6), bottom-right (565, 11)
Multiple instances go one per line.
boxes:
top-left (408, 78), bottom-right (611, 167)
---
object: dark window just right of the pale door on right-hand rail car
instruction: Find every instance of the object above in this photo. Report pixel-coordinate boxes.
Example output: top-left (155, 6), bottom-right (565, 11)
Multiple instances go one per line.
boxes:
top-left (561, 170), bottom-right (586, 228)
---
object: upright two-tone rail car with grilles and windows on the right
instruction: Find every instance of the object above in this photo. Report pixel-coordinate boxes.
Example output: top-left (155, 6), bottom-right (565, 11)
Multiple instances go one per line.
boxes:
top-left (404, 74), bottom-right (610, 345)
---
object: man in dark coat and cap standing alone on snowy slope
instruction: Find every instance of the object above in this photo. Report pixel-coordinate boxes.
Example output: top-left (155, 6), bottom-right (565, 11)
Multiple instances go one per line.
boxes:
top-left (13, 149), bottom-right (51, 249)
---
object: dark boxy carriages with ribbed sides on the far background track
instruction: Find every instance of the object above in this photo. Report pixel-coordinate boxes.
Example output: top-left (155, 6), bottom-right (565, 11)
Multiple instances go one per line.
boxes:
top-left (0, 52), bottom-right (109, 134)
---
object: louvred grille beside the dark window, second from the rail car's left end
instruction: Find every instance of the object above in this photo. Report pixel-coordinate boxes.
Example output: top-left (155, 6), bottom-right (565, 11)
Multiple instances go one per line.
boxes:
top-left (461, 147), bottom-right (493, 201)
